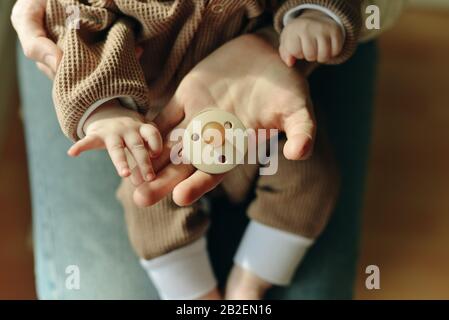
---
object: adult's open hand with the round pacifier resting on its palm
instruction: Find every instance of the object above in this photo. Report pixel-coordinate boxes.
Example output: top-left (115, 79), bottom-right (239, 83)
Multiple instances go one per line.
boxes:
top-left (133, 35), bottom-right (315, 206)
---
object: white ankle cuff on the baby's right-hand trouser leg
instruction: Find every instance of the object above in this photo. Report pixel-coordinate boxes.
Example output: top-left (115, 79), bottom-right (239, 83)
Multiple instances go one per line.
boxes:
top-left (234, 221), bottom-right (313, 285)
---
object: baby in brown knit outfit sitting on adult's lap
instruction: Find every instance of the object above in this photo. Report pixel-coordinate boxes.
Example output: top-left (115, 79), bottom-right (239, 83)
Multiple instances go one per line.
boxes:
top-left (46, 0), bottom-right (361, 299)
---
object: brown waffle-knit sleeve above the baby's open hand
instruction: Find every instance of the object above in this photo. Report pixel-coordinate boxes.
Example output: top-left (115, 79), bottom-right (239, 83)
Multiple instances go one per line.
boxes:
top-left (46, 0), bottom-right (148, 140)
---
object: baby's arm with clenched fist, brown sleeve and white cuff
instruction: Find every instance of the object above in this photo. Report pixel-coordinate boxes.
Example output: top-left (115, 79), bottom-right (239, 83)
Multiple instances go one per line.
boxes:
top-left (274, 0), bottom-right (364, 66)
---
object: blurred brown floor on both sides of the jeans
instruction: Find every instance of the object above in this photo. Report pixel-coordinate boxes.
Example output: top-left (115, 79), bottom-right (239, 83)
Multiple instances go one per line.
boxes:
top-left (0, 7), bottom-right (449, 299)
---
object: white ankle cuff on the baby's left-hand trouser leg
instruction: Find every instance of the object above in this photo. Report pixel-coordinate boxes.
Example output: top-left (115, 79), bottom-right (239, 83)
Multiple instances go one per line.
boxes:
top-left (140, 238), bottom-right (217, 300)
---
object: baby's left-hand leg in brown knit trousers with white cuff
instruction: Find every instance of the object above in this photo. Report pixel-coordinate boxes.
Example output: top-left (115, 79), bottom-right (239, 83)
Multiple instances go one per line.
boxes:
top-left (117, 180), bottom-right (220, 300)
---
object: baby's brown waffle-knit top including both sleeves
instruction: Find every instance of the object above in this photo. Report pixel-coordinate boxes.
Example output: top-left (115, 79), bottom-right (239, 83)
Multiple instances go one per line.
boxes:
top-left (46, 0), bottom-right (361, 140)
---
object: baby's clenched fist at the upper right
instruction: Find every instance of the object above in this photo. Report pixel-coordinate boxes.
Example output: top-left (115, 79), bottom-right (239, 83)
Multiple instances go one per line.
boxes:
top-left (279, 10), bottom-right (344, 67)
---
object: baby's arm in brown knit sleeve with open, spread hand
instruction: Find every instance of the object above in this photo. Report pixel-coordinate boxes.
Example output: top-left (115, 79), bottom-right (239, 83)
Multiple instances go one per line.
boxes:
top-left (45, 0), bottom-right (161, 181)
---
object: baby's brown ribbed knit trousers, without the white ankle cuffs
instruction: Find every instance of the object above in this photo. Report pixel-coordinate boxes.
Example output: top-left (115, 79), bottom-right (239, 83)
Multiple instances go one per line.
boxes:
top-left (117, 134), bottom-right (339, 260)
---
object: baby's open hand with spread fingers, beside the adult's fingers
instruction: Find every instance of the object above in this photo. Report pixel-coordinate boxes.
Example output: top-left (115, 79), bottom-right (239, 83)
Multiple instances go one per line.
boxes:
top-left (68, 100), bottom-right (162, 181)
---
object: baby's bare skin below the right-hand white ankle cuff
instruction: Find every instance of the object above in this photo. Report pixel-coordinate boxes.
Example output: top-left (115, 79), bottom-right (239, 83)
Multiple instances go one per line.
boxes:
top-left (225, 265), bottom-right (272, 300)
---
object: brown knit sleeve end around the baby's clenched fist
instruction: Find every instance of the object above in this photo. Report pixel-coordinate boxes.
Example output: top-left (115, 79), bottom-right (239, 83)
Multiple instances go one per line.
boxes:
top-left (274, 0), bottom-right (363, 64)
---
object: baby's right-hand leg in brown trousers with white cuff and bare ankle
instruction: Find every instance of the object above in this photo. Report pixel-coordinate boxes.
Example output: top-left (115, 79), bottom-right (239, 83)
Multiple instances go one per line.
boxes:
top-left (226, 132), bottom-right (338, 299)
